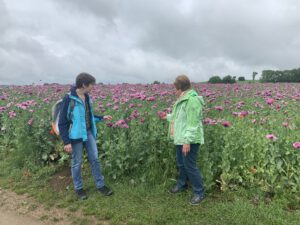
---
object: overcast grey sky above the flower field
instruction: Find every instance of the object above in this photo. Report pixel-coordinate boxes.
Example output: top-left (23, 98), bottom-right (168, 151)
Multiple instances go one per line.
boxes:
top-left (0, 0), bottom-right (300, 84)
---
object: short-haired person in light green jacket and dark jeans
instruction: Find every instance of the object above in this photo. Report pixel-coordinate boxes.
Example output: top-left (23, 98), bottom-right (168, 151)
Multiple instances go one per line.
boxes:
top-left (165, 75), bottom-right (204, 205)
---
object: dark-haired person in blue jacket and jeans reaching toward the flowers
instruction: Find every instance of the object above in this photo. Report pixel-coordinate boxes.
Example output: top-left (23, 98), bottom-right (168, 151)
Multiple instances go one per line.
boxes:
top-left (58, 73), bottom-right (113, 200)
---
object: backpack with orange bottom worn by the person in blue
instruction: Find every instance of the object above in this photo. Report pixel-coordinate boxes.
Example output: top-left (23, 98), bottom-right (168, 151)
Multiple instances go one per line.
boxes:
top-left (51, 94), bottom-right (75, 136)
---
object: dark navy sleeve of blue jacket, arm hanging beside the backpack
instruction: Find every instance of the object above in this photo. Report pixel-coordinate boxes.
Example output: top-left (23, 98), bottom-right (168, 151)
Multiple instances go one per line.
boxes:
top-left (58, 95), bottom-right (71, 145)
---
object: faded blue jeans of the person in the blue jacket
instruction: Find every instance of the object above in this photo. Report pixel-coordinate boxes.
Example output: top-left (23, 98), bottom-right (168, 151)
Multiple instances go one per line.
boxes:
top-left (71, 130), bottom-right (104, 190)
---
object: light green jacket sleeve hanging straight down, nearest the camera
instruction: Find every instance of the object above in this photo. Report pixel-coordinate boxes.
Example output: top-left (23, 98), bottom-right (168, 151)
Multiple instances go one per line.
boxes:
top-left (184, 97), bottom-right (202, 144)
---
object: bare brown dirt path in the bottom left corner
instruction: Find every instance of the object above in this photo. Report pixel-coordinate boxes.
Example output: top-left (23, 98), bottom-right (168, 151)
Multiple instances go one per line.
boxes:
top-left (0, 187), bottom-right (108, 225)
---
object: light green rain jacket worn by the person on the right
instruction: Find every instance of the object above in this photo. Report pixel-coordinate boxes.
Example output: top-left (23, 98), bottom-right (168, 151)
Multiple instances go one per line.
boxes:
top-left (167, 90), bottom-right (204, 145)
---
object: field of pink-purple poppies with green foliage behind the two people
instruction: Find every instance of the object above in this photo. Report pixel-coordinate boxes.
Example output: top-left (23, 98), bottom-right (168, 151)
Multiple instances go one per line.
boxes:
top-left (0, 83), bottom-right (300, 197)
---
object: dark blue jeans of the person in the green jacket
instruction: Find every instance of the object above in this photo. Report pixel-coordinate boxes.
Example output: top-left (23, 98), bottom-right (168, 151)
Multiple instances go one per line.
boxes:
top-left (176, 144), bottom-right (204, 195)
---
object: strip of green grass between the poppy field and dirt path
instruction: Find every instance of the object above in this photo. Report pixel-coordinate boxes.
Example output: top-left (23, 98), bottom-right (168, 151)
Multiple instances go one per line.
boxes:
top-left (0, 156), bottom-right (300, 225)
